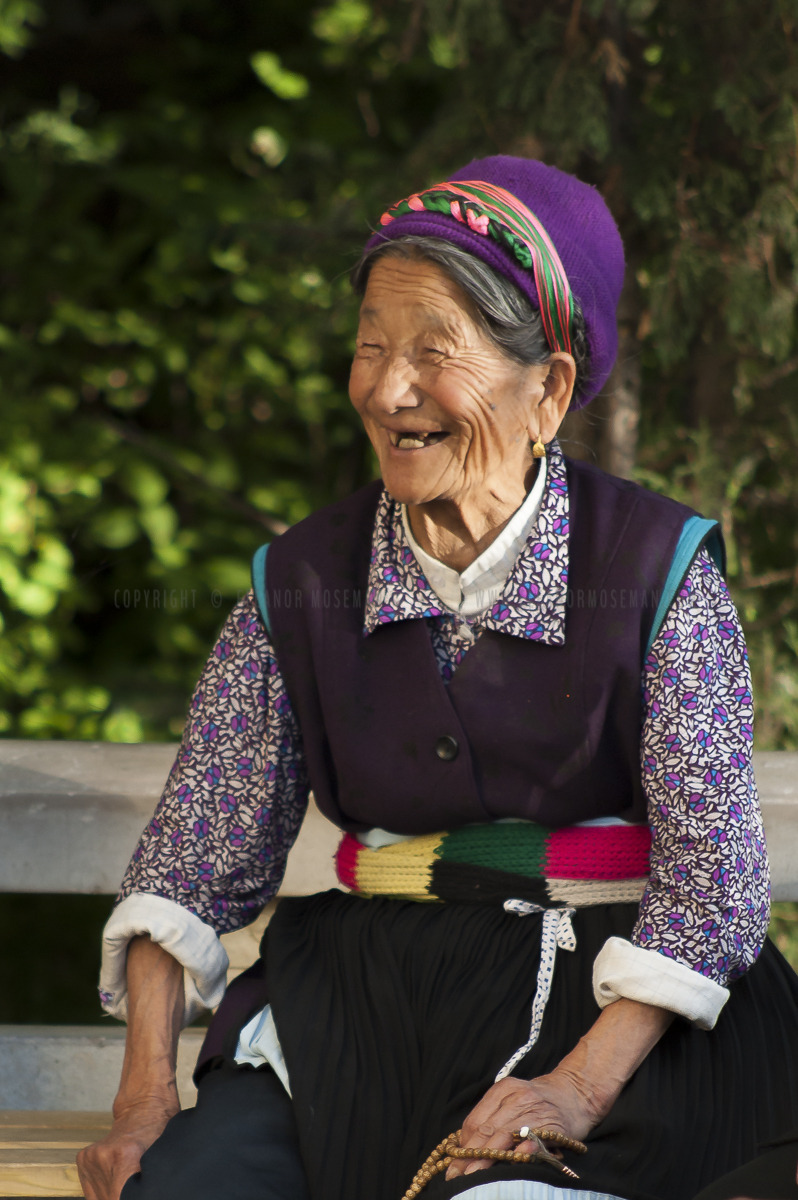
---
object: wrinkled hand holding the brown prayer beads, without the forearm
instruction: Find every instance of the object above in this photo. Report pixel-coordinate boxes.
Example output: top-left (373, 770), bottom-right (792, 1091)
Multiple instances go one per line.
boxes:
top-left (446, 1070), bottom-right (604, 1180)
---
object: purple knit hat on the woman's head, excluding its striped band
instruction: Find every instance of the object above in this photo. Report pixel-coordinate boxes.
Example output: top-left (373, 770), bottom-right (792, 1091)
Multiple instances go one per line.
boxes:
top-left (366, 155), bottom-right (624, 408)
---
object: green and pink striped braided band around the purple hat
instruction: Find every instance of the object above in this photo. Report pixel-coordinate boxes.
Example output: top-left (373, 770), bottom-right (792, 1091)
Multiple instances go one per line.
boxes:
top-left (379, 180), bottom-right (574, 354)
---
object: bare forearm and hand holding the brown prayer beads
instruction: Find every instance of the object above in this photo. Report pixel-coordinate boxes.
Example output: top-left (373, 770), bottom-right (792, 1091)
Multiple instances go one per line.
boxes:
top-left (446, 1000), bottom-right (673, 1180)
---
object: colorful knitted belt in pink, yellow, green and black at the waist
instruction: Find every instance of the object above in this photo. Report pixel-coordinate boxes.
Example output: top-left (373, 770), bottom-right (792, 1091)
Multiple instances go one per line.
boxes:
top-left (336, 821), bottom-right (652, 908)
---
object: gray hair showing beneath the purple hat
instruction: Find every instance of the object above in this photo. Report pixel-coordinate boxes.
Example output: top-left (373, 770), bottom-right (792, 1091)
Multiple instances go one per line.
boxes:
top-left (350, 234), bottom-right (589, 391)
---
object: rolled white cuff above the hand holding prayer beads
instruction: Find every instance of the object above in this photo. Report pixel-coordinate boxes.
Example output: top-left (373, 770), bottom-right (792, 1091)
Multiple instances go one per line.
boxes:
top-left (593, 937), bottom-right (728, 1030)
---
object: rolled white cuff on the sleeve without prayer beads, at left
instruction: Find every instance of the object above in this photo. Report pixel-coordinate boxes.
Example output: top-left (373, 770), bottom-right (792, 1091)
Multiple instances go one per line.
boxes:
top-left (100, 892), bottom-right (228, 1025)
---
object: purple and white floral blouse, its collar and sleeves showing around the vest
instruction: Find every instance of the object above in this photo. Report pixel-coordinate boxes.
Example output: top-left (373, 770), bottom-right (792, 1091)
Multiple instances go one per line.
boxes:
top-left (110, 443), bottom-right (769, 1010)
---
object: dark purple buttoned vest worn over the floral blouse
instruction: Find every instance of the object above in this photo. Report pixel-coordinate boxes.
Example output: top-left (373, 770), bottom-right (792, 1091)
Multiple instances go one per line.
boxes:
top-left (265, 462), bottom-right (691, 834)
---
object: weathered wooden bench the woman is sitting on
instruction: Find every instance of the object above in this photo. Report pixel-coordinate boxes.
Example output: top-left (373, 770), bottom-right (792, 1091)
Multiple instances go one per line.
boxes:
top-left (0, 740), bottom-right (798, 1198)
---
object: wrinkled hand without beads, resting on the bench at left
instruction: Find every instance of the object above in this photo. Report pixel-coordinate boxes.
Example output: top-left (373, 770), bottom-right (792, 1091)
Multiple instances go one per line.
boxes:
top-left (77, 1096), bottom-right (180, 1200)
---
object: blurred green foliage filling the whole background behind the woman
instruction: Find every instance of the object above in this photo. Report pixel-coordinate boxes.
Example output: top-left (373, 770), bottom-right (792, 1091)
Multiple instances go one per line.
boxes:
top-left (0, 0), bottom-right (798, 745)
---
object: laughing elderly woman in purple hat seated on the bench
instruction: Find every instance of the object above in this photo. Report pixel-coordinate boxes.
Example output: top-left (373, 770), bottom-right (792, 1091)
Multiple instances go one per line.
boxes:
top-left (80, 157), bottom-right (798, 1200)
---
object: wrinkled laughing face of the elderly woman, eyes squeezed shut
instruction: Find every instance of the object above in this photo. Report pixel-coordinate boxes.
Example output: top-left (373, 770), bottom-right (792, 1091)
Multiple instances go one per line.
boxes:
top-left (349, 257), bottom-right (548, 505)
